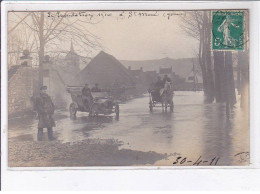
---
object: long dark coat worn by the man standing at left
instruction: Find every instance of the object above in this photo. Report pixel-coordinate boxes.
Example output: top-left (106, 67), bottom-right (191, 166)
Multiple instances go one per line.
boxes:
top-left (36, 94), bottom-right (55, 128)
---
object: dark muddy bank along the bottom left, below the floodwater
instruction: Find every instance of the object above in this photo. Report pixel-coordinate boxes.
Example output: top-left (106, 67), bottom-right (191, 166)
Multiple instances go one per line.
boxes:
top-left (8, 140), bottom-right (167, 167)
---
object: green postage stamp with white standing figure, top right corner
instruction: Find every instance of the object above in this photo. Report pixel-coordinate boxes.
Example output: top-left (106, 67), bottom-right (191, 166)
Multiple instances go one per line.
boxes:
top-left (212, 11), bottom-right (244, 51)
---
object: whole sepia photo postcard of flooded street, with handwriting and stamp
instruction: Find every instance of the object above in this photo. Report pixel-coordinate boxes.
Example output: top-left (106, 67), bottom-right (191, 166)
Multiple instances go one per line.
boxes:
top-left (7, 9), bottom-right (250, 167)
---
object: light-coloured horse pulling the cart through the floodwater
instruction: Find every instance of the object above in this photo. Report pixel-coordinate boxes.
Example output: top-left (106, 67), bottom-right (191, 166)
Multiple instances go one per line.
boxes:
top-left (161, 81), bottom-right (173, 112)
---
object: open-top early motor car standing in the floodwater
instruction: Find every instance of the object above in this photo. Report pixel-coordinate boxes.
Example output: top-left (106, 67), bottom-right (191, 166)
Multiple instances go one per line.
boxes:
top-left (67, 86), bottom-right (119, 119)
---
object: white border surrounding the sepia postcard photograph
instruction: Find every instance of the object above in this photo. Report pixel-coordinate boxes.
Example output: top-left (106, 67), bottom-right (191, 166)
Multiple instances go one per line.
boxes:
top-left (1, 1), bottom-right (260, 190)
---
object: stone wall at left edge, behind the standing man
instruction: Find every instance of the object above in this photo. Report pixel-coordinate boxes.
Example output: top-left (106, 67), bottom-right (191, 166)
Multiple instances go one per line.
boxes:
top-left (8, 66), bottom-right (37, 116)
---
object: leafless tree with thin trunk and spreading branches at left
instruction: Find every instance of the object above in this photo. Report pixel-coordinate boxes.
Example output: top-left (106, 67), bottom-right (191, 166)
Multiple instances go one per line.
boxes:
top-left (9, 12), bottom-right (101, 86)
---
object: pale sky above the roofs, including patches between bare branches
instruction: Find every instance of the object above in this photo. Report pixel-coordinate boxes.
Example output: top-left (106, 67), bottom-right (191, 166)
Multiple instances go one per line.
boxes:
top-left (9, 11), bottom-right (198, 60)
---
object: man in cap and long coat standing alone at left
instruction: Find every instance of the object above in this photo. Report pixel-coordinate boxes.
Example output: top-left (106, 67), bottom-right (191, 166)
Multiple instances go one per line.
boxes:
top-left (36, 86), bottom-right (55, 141)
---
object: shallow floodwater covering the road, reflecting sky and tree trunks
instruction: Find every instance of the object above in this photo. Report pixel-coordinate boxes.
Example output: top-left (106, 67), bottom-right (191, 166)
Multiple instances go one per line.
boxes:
top-left (8, 92), bottom-right (249, 166)
